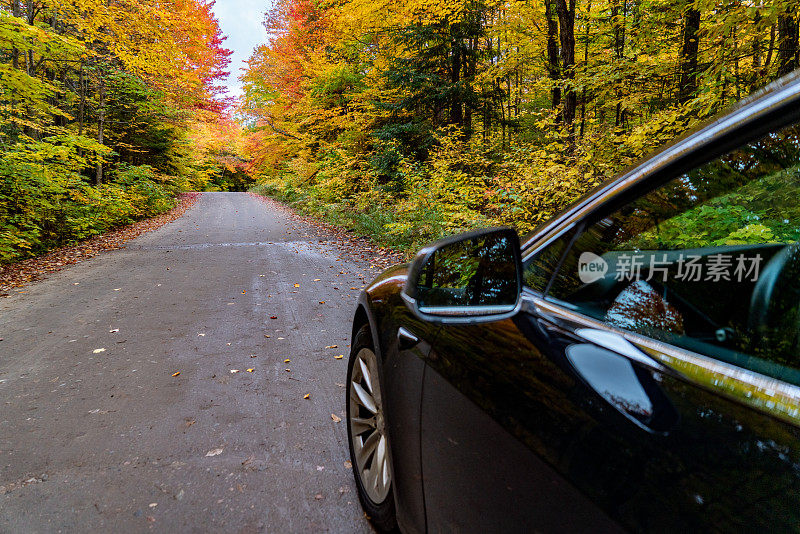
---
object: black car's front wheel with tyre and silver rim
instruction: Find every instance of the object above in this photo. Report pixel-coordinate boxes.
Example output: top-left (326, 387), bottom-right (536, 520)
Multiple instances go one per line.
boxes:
top-left (347, 325), bottom-right (397, 531)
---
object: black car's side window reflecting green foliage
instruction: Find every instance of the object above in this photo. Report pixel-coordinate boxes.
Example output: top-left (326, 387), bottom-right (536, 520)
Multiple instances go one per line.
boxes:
top-left (548, 119), bottom-right (800, 384)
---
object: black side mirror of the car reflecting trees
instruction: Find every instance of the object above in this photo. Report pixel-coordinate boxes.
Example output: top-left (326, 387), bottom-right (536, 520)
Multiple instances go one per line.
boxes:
top-left (401, 228), bottom-right (522, 323)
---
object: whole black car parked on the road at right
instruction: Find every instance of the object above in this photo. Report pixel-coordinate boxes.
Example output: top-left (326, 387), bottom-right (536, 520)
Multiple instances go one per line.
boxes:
top-left (347, 75), bottom-right (800, 532)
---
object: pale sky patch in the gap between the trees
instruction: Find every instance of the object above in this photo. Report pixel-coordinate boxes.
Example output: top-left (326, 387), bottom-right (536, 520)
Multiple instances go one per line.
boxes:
top-left (209, 0), bottom-right (272, 97)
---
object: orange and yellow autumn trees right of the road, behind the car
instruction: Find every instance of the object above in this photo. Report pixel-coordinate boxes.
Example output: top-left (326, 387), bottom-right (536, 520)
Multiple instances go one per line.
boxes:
top-left (242, 0), bottom-right (800, 252)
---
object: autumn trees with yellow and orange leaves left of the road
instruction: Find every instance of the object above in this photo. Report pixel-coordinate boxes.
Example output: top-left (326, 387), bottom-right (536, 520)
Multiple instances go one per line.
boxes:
top-left (0, 0), bottom-right (247, 263)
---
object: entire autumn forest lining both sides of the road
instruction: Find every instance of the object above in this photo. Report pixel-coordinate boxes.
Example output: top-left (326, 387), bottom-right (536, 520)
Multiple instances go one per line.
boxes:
top-left (0, 0), bottom-right (800, 263)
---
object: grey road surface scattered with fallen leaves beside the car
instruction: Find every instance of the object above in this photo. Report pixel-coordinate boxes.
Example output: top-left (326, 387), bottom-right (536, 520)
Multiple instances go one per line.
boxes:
top-left (0, 193), bottom-right (379, 533)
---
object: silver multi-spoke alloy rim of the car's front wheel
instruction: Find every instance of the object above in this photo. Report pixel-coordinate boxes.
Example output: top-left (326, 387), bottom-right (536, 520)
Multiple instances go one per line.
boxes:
top-left (348, 348), bottom-right (392, 504)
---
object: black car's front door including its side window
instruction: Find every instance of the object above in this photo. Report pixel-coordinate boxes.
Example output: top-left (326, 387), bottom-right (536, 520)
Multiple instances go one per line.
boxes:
top-left (421, 113), bottom-right (800, 532)
